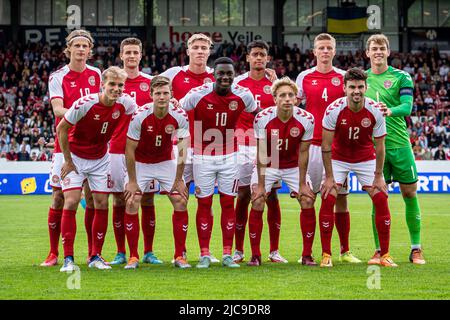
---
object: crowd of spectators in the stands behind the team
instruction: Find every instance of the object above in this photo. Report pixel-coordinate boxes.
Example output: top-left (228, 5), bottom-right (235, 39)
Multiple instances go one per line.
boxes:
top-left (0, 38), bottom-right (450, 161)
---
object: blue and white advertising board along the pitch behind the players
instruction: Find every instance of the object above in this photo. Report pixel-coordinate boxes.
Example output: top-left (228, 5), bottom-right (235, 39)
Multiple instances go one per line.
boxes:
top-left (0, 161), bottom-right (450, 195)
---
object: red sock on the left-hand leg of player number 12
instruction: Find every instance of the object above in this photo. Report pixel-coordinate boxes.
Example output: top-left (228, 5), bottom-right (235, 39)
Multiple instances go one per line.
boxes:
top-left (319, 194), bottom-right (336, 255)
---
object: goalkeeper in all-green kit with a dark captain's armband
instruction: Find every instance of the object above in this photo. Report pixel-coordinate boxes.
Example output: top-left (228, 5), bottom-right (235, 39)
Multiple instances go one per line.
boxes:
top-left (366, 34), bottom-right (425, 264)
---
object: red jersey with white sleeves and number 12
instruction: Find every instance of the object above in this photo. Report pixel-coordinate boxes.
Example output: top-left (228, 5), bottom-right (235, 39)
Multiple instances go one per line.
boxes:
top-left (322, 97), bottom-right (386, 163)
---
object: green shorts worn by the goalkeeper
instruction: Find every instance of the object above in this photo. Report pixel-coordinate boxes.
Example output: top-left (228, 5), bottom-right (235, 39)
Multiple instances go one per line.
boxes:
top-left (383, 147), bottom-right (418, 184)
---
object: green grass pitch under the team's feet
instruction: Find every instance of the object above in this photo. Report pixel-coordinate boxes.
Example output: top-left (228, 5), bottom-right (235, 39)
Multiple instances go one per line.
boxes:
top-left (0, 194), bottom-right (450, 300)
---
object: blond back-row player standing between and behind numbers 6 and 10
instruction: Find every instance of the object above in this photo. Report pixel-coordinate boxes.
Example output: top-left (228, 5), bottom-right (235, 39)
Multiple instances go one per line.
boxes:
top-left (161, 33), bottom-right (220, 262)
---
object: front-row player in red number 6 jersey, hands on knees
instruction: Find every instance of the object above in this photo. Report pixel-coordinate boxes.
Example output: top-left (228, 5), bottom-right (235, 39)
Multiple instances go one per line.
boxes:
top-left (125, 76), bottom-right (191, 269)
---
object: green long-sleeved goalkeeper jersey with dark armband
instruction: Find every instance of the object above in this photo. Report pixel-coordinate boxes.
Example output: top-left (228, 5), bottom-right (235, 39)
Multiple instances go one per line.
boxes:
top-left (366, 66), bottom-right (414, 149)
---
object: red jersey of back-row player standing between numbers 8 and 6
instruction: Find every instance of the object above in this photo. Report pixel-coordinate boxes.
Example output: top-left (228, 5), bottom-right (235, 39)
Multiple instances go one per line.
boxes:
top-left (109, 72), bottom-right (153, 154)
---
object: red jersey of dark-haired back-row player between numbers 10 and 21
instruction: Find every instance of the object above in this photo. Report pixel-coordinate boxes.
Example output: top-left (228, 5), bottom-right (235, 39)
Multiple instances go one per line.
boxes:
top-left (234, 72), bottom-right (275, 146)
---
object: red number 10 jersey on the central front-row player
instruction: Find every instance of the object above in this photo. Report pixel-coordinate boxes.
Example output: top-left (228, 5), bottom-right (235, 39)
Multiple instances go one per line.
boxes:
top-left (180, 83), bottom-right (257, 156)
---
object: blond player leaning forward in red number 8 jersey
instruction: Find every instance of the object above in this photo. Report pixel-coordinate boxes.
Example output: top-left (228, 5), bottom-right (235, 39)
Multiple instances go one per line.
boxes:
top-left (57, 67), bottom-right (137, 272)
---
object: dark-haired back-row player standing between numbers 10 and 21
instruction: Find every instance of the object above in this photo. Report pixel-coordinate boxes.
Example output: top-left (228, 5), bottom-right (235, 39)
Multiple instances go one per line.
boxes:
top-left (233, 40), bottom-right (288, 263)
